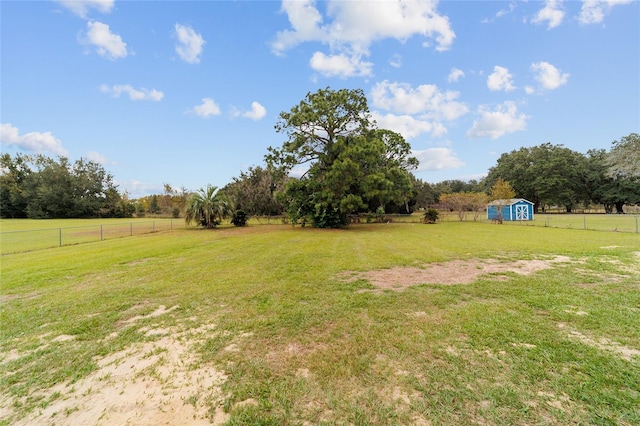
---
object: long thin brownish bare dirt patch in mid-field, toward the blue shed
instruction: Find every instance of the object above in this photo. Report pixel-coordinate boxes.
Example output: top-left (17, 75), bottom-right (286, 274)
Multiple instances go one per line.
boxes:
top-left (340, 256), bottom-right (571, 292)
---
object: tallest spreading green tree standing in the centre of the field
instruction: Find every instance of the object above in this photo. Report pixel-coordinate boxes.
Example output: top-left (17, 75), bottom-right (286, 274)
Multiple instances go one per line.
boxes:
top-left (266, 88), bottom-right (417, 228)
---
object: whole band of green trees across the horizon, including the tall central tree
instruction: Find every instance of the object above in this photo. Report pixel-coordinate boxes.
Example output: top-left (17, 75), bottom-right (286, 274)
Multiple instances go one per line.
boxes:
top-left (0, 88), bottom-right (640, 227)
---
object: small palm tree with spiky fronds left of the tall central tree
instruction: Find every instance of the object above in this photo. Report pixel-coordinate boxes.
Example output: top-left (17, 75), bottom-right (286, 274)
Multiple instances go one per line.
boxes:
top-left (184, 185), bottom-right (231, 228)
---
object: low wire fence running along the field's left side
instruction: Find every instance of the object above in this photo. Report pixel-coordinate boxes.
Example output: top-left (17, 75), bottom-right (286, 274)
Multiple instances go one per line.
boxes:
top-left (0, 219), bottom-right (184, 254)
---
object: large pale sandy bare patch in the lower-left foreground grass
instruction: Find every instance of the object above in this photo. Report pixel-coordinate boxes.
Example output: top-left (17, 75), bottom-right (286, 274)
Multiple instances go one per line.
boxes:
top-left (0, 307), bottom-right (229, 426)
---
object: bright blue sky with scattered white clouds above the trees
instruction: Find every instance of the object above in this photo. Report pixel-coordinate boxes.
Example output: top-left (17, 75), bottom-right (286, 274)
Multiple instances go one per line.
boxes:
top-left (0, 0), bottom-right (640, 198)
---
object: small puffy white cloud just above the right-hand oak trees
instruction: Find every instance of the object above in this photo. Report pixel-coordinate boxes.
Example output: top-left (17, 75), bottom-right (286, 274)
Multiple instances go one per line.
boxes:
top-left (467, 101), bottom-right (529, 139)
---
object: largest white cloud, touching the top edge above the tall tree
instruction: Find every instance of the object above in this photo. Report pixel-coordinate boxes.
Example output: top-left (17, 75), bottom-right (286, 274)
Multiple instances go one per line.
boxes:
top-left (271, 0), bottom-right (455, 77)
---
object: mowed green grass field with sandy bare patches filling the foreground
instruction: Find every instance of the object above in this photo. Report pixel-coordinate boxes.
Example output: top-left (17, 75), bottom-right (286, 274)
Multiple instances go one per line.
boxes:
top-left (0, 221), bottom-right (640, 425)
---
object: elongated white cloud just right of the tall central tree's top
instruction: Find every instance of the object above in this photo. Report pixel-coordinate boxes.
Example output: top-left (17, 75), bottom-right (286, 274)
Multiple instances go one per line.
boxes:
top-left (371, 80), bottom-right (469, 121)
